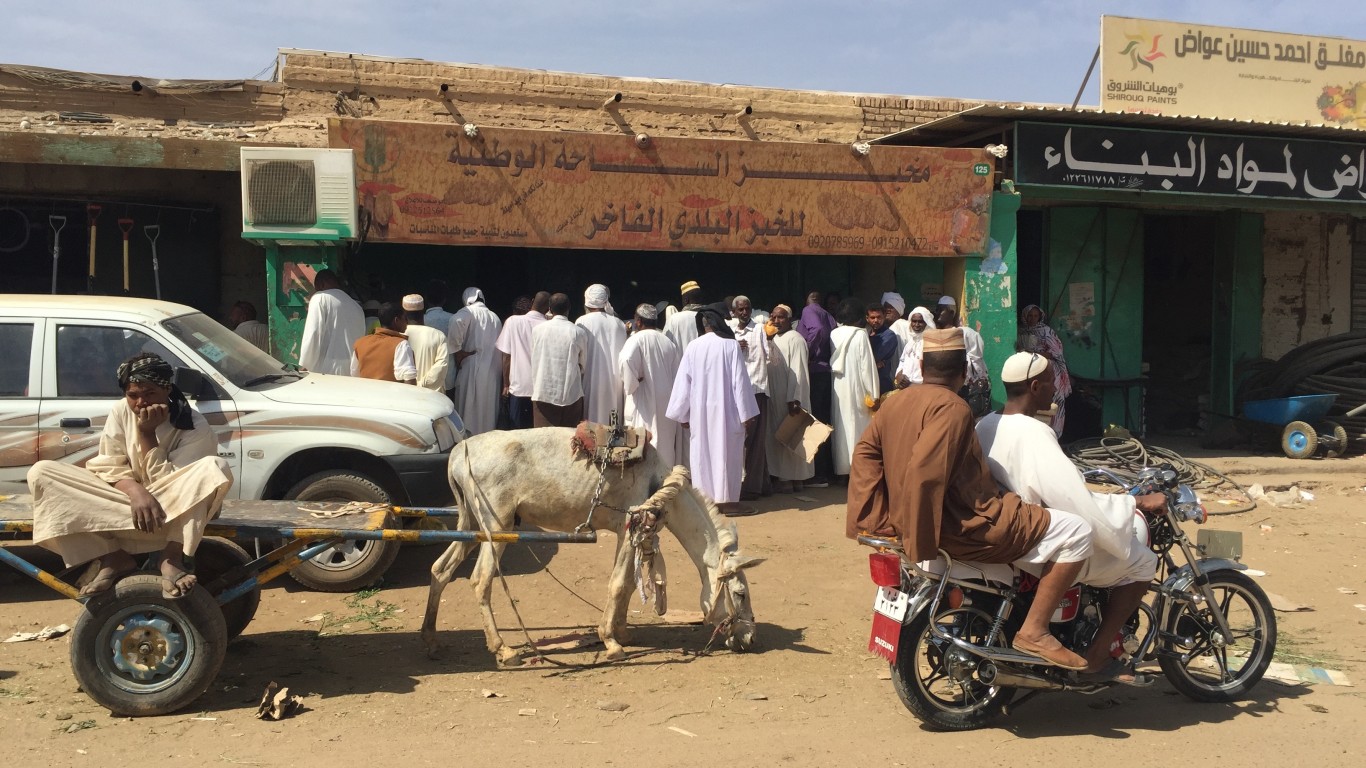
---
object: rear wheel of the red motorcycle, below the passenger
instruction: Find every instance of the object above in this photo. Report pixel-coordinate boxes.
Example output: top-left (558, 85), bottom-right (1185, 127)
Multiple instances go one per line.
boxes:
top-left (892, 608), bottom-right (1015, 731)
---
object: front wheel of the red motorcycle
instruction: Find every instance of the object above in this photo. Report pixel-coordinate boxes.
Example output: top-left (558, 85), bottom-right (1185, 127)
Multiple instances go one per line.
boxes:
top-left (1158, 571), bottom-right (1276, 702)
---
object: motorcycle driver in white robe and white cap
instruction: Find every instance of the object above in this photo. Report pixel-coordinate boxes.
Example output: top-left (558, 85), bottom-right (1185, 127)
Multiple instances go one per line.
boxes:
top-left (977, 353), bottom-right (1165, 683)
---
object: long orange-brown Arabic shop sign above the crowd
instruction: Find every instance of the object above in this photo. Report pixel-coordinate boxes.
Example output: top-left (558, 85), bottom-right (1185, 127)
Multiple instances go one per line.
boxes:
top-left (329, 119), bottom-right (992, 257)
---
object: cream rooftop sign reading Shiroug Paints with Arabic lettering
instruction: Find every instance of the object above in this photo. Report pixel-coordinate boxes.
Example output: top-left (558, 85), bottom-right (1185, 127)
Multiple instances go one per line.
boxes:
top-left (1101, 16), bottom-right (1366, 128)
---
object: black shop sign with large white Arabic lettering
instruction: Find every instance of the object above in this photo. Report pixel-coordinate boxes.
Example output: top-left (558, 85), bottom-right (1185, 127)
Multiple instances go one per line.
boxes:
top-left (1015, 123), bottom-right (1366, 202)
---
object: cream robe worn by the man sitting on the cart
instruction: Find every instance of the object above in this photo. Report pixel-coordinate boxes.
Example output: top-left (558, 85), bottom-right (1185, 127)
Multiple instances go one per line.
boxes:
top-left (29, 399), bottom-right (232, 566)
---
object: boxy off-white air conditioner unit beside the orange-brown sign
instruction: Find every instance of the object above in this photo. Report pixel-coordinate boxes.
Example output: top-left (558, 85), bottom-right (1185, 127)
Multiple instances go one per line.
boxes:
top-left (242, 146), bottom-right (359, 245)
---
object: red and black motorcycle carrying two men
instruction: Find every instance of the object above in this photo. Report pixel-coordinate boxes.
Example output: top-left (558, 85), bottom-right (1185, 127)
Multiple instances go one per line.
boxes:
top-left (858, 467), bottom-right (1276, 731)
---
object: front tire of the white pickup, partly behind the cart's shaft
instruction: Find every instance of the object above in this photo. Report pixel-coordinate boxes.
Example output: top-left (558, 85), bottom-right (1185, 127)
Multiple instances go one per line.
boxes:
top-left (284, 470), bottom-right (400, 592)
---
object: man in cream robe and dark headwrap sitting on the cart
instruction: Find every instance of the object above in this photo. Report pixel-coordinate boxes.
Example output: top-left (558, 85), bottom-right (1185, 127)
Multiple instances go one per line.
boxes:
top-left (29, 353), bottom-right (232, 599)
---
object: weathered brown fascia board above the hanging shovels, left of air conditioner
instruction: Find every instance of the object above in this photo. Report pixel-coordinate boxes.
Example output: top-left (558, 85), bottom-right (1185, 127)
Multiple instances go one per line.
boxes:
top-left (0, 133), bottom-right (251, 172)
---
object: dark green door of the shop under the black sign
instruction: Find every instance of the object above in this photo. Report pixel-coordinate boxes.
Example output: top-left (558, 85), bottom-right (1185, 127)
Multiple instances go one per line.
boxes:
top-left (1044, 206), bottom-right (1143, 433)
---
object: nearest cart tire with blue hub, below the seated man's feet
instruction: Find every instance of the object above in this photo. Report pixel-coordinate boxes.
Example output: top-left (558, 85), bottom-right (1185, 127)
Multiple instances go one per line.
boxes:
top-left (71, 574), bottom-right (228, 717)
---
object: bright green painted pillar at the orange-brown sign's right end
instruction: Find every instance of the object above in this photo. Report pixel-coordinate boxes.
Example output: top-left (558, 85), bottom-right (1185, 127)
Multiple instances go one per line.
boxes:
top-left (963, 193), bottom-right (1020, 407)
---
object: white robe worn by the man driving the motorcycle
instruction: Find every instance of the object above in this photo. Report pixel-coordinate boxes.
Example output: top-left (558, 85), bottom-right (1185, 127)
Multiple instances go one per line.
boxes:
top-left (977, 413), bottom-right (1157, 586)
